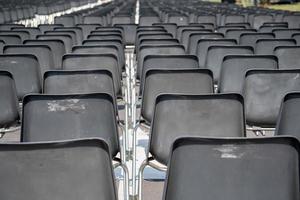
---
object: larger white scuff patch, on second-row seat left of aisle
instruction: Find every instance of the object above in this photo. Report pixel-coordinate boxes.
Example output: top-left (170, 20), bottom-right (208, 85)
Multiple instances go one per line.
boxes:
top-left (47, 99), bottom-right (86, 112)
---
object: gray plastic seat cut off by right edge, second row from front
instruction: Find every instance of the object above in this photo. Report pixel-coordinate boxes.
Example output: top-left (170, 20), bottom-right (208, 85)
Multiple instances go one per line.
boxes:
top-left (275, 92), bottom-right (300, 139)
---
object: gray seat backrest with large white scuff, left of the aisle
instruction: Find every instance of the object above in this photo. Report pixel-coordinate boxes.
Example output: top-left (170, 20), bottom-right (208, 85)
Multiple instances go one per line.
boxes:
top-left (21, 93), bottom-right (119, 156)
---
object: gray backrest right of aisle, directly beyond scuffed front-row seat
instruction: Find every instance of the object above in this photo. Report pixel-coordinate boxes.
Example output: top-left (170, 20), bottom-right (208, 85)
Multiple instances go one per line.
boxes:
top-left (149, 94), bottom-right (245, 165)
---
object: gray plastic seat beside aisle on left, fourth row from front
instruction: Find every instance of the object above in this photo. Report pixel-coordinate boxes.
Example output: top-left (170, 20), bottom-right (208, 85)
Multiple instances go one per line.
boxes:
top-left (62, 54), bottom-right (121, 93)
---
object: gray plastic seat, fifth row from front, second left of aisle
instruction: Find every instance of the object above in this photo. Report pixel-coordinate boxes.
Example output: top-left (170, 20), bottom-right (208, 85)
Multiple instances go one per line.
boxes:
top-left (4, 45), bottom-right (54, 76)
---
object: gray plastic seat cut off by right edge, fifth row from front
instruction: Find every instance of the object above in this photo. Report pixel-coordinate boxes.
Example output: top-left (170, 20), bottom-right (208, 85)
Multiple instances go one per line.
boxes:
top-left (274, 46), bottom-right (300, 69)
